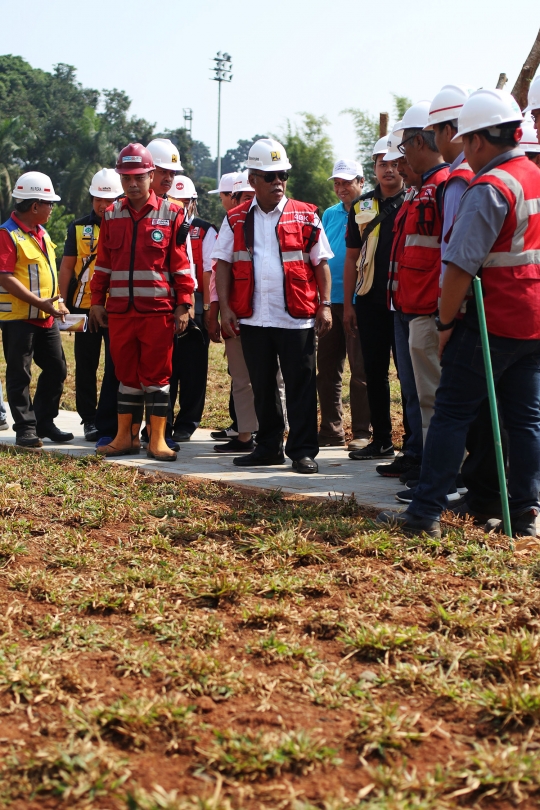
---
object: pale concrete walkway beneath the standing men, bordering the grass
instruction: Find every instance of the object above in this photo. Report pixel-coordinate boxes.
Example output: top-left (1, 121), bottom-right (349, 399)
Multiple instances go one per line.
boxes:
top-left (0, 411), bottom-right (403, 509)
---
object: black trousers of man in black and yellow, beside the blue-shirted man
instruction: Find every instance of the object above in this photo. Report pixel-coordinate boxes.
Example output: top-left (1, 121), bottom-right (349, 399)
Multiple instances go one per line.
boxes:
top-left (356, 296), bottom-right (395, 447)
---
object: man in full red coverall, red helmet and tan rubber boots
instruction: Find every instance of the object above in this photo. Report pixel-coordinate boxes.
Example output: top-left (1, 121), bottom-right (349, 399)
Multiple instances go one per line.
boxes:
top-left (90, 143), bottom-right (194, 461)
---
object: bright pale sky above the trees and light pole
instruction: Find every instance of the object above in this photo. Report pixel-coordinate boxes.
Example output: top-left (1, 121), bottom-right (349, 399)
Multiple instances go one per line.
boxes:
top-left (0, 0), bottom-right (540, 167)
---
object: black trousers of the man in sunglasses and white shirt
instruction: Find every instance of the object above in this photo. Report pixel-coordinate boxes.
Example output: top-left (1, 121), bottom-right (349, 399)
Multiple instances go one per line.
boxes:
top-left (240, 324), bottom-right (319, 460)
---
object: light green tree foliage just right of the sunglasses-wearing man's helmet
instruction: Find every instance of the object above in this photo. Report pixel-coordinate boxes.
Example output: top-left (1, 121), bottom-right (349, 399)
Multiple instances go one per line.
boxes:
top-left (280, 113), bottom-right (336, 214)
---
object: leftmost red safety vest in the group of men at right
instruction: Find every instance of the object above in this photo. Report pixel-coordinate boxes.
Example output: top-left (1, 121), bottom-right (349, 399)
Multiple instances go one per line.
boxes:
top-left (396, 166), bottom-right (449, 315)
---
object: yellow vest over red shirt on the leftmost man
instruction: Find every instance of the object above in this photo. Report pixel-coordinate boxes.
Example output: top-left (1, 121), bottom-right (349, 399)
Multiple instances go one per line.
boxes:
top-left (0, 217), bottom-right (59, 321)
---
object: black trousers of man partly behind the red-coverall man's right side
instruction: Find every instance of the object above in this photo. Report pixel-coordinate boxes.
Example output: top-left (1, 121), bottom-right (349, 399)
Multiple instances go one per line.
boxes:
top-left (170, 315), bottom-right (210, 434)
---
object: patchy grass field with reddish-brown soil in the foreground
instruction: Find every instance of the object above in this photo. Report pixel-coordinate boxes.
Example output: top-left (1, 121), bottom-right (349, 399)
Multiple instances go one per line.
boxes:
top-left (0, 453), bottom-right (540, 810)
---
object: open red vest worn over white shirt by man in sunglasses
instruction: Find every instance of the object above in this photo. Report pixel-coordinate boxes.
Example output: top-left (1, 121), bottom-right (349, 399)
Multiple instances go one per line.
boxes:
top-left (227, 200), bottom-right (320, 318)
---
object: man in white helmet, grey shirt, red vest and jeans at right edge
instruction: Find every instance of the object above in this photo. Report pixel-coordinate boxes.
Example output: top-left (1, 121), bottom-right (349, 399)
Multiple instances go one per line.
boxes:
top-left (377, 90), bottom-right (540, 537)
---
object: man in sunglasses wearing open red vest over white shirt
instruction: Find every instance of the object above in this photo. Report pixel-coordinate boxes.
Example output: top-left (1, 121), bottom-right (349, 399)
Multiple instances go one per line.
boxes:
top-left (213, 138), bottom-right (333, 473)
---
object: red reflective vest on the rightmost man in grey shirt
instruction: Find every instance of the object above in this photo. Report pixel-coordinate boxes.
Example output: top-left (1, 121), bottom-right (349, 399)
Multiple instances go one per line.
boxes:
top-left (465, 155), bottom-right (540, 340)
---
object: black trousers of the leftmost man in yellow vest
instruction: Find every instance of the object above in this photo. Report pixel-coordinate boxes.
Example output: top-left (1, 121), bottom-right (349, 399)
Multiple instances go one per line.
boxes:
top-left (1, 321), bottom-right (67, 435)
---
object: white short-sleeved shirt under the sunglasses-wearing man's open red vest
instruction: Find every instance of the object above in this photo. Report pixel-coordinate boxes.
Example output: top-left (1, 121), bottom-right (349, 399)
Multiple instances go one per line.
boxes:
top-left (212, 196), bottom-right (334, 329)
